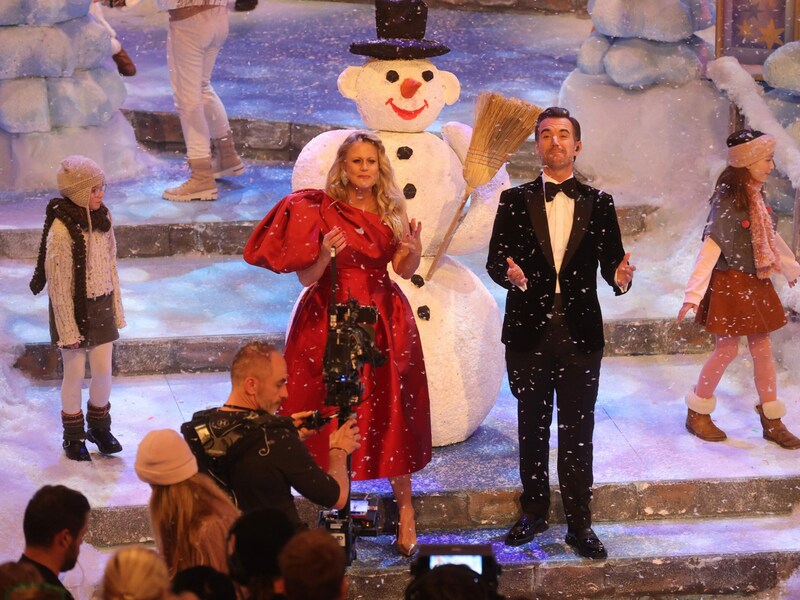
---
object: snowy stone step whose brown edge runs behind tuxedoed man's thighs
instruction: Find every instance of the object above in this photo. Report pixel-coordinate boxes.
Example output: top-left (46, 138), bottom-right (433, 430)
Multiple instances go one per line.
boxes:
top-left (0, 248), bottom-right (710, 379)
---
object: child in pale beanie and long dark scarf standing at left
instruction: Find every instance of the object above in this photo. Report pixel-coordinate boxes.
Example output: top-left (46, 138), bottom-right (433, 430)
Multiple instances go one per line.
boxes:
top-left (30, 155), bottom-right (125, 461)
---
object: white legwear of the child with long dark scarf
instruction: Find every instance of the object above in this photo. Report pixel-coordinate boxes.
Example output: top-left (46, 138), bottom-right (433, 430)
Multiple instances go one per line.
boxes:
top-left (61, 342), bottom-right (113, 415)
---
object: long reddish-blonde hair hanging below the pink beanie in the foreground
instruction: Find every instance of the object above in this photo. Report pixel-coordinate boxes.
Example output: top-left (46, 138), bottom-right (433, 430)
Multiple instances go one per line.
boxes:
top-left (150, 473), bottom-right (239, 576)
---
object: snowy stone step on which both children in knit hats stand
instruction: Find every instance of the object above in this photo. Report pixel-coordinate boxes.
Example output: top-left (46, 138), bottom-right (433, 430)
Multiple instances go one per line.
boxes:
top-left (31, 356), bottom-right (800, 545)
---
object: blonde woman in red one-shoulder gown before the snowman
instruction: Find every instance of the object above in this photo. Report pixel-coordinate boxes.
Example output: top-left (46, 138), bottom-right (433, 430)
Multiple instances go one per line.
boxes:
top-left (241, 131), bottom-right (431, 555)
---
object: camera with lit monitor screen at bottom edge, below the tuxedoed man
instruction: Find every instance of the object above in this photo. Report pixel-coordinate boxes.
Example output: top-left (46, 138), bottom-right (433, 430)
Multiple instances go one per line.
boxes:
top-left (405, 544), bottom-right (503, 600)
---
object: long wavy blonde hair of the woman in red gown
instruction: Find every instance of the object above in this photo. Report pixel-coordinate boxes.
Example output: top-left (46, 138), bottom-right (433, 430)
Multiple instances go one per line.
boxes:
top-left (325, 131), bottom-right (406, 240)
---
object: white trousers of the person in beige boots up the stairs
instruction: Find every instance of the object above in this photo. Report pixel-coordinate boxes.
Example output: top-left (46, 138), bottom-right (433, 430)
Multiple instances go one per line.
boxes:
top-left (167, 6), bottom-right (230, 159)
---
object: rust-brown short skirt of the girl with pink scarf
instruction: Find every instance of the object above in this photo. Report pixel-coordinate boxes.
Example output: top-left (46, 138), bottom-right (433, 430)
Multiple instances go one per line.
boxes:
top-left (695, 269), bottom-right (786, 336)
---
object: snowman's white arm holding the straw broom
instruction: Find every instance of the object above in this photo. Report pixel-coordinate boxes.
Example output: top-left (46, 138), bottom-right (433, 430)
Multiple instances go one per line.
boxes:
top-left (442, 121), bottom-right (511, 255)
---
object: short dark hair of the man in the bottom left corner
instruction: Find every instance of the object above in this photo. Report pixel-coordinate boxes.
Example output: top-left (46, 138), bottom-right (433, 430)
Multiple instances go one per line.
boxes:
top-left (22, 485), bottom-right (90, 548)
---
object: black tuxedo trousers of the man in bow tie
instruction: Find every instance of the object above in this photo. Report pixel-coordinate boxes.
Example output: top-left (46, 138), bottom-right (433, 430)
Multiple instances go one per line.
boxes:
top-left (506, 295), bottom-right (603, 530)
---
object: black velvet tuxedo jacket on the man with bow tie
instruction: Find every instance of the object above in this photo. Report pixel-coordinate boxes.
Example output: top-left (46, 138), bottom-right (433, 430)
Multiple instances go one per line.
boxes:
top-left (486, 177), bottom-right (630, 353)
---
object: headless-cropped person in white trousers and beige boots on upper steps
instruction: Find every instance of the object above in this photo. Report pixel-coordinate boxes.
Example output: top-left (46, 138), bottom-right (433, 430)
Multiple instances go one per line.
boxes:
top-left (157, 0), bottom-right (244, 202)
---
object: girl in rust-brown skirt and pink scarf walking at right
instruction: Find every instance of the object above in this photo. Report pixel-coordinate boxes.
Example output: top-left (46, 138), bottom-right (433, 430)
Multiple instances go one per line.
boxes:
top-left (678, 129), bottom-right (800, 449)
